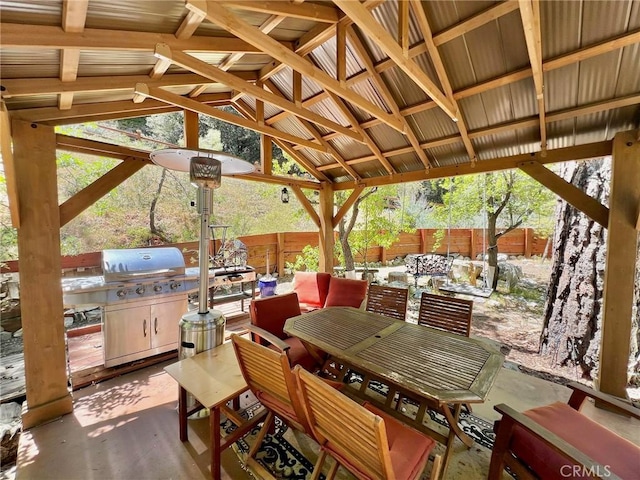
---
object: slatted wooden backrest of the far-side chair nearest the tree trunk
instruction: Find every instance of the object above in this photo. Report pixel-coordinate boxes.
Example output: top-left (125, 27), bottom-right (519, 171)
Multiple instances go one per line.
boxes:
top-left (418, 292), bottom-right (473, 337)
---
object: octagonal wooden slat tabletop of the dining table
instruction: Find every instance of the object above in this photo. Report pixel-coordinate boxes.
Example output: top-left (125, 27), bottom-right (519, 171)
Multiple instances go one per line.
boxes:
top-left (284, 307), bottom-right (504, 403)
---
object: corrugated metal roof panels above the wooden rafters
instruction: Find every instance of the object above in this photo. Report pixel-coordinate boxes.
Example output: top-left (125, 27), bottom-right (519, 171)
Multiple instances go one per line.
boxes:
top-left (0, 0), bottom-right (640, 188)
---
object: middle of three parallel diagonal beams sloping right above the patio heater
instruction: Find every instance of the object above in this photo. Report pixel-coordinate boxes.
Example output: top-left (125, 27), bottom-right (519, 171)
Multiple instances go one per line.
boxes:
top-left (155, 44), bottom-right (363, 142)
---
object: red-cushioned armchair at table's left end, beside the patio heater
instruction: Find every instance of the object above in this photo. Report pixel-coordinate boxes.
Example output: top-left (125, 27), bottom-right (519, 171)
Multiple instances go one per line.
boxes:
top-left (249, 292), bottom-right (321, 371)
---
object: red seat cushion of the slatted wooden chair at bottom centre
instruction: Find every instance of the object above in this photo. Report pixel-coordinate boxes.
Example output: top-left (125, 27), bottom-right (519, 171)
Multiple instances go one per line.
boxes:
top-left (363, 402), bottom-right (436, 480)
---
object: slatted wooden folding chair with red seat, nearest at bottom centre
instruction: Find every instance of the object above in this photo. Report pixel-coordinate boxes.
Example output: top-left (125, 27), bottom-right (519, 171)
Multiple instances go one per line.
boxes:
top-left (293, 367), bottom-right (440, 480)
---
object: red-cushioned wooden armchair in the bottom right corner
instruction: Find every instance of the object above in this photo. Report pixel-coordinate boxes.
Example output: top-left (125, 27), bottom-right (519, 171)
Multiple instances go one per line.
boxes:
top-left (489, 383), bottom-right (640, 480)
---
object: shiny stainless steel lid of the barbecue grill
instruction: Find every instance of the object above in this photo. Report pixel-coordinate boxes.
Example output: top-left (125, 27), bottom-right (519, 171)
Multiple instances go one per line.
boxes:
top-left (102, 247), bottom-right (185, 283)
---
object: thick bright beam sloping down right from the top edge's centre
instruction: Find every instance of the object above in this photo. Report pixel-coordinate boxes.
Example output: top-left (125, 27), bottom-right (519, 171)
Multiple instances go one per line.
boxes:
top-left (334, 0), bottom-right (457, 121)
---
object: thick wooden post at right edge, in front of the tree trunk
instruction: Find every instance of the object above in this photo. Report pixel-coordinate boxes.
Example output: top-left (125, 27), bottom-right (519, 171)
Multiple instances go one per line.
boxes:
top-left (598, 131), bottom-right (640, 398)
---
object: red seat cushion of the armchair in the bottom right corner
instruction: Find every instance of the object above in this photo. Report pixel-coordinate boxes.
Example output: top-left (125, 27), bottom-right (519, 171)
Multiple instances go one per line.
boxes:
top-left (510, 402), bottom-right (640, 480)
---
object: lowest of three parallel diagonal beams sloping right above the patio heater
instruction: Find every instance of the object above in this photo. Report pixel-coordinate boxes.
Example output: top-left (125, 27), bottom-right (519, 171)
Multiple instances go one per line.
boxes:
top-left (136, 83), bottom-right (326, 152)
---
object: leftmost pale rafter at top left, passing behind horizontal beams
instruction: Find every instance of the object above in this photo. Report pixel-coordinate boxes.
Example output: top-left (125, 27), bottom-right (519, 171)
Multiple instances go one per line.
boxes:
top-left (58, 0), bottom-right (89, 110)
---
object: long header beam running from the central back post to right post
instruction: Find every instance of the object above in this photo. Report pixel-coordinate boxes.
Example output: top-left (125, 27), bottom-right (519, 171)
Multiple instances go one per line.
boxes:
top-left (333, 141), bottom-right (611, 190)
